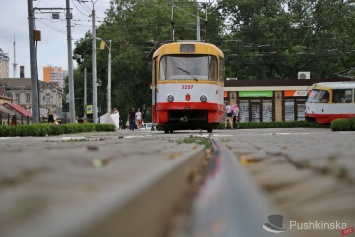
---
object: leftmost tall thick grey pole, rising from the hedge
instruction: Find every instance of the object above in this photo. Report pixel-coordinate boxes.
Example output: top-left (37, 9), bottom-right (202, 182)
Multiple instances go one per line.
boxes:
top-left (27, 0), bottom-right (39, 123)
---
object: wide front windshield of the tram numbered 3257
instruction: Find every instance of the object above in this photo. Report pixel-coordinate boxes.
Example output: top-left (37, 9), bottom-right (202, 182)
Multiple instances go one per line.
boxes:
top-left (159, 55), bottom-right (218, 81)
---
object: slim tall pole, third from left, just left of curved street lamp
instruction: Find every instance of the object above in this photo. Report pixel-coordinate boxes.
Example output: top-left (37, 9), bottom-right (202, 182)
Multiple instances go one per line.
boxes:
top-left (92, 6), bottom-right (97, 123)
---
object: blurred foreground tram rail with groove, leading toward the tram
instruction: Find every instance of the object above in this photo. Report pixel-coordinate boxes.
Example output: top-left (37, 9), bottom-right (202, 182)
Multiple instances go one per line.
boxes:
top-left (0, 131), bottom-right (312, 237)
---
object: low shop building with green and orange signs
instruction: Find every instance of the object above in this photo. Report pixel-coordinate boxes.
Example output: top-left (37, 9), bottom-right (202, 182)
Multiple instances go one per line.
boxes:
top-left (224, 78), bottom-right (350, 122)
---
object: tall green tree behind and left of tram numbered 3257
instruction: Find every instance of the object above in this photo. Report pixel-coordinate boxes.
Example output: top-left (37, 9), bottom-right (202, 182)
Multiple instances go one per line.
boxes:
top-left (74, 0), bottom-right (218, 121)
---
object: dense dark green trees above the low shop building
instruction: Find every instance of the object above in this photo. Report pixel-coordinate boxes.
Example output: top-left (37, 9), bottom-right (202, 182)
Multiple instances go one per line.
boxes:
top-left (218, 0), bottom-right (355, 80)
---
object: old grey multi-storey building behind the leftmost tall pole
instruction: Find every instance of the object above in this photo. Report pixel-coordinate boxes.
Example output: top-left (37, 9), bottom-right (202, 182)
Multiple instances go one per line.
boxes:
top-left (0, 78), bottom-right (63, 115)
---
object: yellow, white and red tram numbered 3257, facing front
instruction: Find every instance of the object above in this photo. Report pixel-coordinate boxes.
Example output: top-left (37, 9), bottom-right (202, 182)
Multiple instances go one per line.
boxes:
top-left (152, 41), bottom-right (224, 133)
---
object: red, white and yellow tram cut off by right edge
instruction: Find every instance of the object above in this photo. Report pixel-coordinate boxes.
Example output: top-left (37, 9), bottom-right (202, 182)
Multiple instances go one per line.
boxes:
top-left (305, 81), bottom-right (355, 124)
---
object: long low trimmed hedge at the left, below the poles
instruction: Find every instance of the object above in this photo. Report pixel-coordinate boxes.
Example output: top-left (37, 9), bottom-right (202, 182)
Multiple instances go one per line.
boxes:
top-left (0, 123), bottom-right (116, 137)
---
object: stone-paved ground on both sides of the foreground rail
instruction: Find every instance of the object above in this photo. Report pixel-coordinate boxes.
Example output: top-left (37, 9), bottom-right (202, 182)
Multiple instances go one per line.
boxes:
top-left (0, 128), bottom-right (355, 236)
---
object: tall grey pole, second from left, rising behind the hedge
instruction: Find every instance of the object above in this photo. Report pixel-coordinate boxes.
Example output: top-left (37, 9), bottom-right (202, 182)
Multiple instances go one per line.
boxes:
top-left (66, 0), bottom-right (75, 123)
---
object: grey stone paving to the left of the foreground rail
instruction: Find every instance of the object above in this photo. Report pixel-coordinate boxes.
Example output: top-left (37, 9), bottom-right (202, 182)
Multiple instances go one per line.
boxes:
top-left (0, 130), bottom-right (203, 237)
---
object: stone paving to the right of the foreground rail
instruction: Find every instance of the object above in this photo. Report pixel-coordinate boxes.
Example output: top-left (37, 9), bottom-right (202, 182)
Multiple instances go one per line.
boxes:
top-left (223, 128), bottom-right (355, 237)
